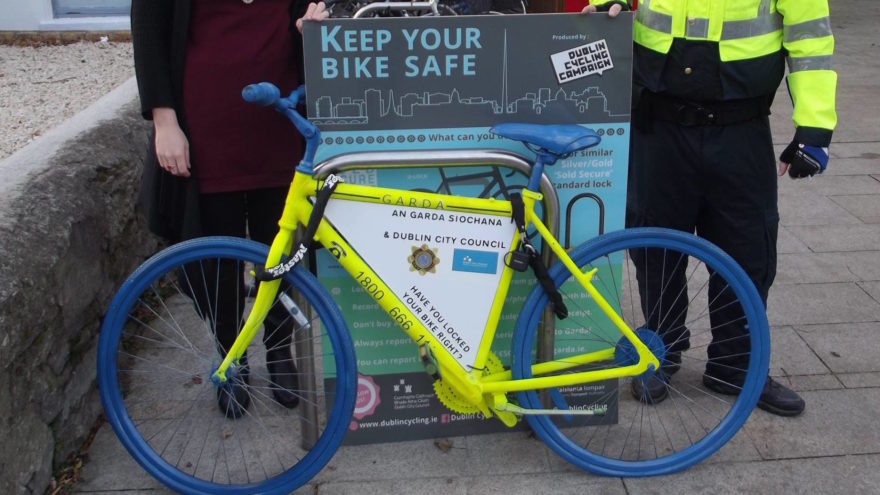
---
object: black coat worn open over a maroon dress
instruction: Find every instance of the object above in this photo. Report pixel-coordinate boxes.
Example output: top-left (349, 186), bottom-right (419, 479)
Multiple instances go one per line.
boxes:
top-left (131, 0), bottom-right (308, 242)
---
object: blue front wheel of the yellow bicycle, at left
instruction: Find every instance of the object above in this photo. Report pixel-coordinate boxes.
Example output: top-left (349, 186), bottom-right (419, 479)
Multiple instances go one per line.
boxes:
top-left (98, 237), bottom-right (356, 494)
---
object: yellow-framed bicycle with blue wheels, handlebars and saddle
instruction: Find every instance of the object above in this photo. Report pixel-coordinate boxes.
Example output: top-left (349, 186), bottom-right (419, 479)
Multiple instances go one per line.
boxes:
top-left (98, 83), bottom-right (769, 493)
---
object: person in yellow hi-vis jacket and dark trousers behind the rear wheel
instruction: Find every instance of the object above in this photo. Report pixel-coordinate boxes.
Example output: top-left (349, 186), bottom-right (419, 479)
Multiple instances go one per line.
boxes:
top-left (583, 0), bottom-right (837, 416)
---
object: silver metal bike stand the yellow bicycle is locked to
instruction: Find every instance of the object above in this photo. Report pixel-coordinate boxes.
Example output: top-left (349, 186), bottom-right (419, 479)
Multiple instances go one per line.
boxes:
top-left (296, 149), bottom-right (559, 448)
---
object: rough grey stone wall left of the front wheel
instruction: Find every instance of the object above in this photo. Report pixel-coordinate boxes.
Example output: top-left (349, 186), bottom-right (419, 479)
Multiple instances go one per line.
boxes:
top-left (0, 79), bottom-right (157, 494)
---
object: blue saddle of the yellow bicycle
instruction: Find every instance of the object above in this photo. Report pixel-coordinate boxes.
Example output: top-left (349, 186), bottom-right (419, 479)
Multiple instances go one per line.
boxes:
top-left (489, 122), bottom-right (602, 156)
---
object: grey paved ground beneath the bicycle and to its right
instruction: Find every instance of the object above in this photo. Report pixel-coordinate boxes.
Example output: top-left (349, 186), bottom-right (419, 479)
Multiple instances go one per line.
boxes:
top-left (75, 0), bottom-right (880, 495)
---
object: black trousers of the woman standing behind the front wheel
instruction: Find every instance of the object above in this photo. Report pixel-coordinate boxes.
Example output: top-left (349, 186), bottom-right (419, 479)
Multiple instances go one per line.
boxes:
top-left (186, 187), bottom-right (293, 353)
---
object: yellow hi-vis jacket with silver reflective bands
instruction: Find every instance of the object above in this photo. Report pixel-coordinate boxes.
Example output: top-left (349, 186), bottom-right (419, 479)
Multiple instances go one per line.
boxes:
top-left (591, 0), bottom-right (837, 144)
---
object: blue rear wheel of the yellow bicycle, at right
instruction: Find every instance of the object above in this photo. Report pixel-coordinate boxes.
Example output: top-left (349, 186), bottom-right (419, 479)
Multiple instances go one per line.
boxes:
top-left (512, 228), bottom-right (770, 476)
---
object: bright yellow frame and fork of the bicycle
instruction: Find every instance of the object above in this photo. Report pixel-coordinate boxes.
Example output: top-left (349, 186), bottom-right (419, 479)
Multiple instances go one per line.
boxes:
top-left (214, 172), bottom-right (660, 424)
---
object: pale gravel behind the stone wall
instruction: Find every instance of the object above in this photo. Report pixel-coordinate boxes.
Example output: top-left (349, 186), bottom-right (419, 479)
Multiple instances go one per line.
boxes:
top-left (0, 40), bottom-right (134, 160)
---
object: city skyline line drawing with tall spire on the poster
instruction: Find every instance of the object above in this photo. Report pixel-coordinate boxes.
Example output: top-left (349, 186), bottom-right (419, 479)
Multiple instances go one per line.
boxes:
top-left (309, 29), bottom-right (629, 130)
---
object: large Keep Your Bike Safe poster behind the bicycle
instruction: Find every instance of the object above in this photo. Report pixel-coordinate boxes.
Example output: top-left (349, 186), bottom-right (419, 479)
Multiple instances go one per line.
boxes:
top-left (303, 14), bottom-right (632, 443)
